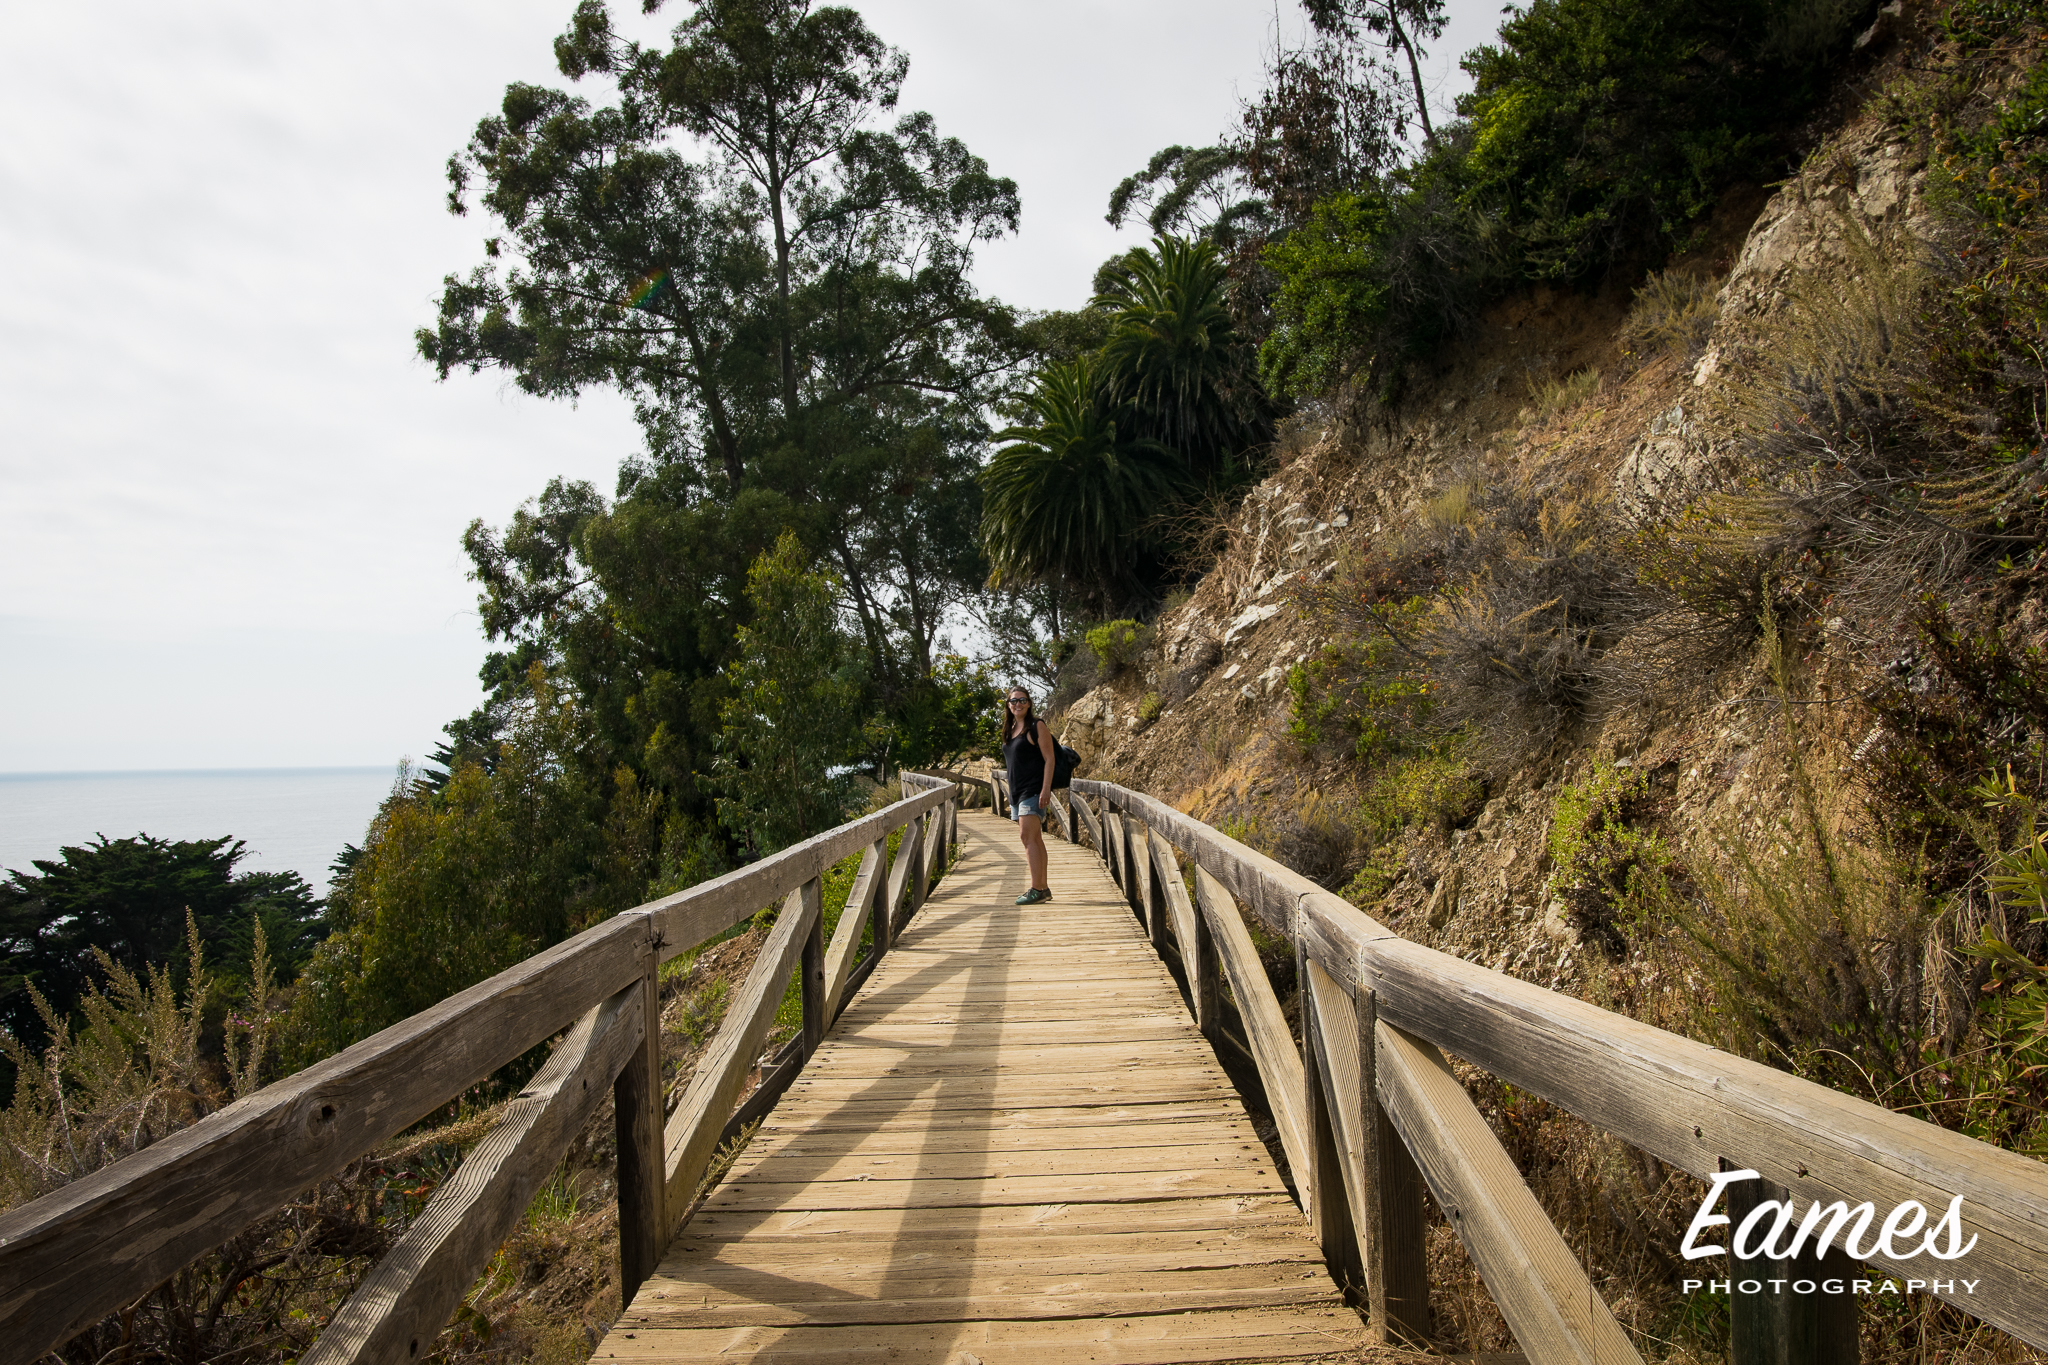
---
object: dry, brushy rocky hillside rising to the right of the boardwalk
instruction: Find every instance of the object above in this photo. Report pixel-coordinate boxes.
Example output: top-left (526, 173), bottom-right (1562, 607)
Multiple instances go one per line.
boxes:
top-left (1055, 4), bottom-right (2048, 1361)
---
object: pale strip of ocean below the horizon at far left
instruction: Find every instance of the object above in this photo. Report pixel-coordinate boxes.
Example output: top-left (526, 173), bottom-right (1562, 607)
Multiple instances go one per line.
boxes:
top-left (0, 767), bottom-right (395, 894)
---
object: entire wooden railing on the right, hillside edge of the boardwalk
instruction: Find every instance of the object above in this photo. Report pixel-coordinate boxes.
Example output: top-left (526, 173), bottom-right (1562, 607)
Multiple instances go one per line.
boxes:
top-left (1071, 780), bottom-right (2048, 1365)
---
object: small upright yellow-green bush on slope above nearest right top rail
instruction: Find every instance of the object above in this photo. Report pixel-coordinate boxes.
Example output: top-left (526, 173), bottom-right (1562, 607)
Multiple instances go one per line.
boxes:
top-left (1548, 759), bottom-right (1677, 956)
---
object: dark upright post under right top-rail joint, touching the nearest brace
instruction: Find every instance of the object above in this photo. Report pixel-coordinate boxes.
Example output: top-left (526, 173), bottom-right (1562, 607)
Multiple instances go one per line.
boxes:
top-left (1354, 990), bottom-right (1430, 1345)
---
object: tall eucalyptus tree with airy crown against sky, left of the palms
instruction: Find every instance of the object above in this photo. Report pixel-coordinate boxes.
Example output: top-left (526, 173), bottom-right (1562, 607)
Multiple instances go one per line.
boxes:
top-left (418, 0), bottom-right (1020, 822)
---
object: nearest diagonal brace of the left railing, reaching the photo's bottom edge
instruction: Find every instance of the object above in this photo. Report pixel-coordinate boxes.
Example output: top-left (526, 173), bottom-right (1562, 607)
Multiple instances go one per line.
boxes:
top-left (299, 982), bottom-right (645, 1365)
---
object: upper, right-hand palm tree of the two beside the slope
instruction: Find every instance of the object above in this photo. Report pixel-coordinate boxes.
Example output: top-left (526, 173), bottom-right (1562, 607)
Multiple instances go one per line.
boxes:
top-left (1094, 237), bottom-right (1270, 481)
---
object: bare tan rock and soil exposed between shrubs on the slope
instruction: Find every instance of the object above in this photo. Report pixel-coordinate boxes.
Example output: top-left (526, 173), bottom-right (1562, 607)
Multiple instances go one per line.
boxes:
top-left (1055, 6), bottom-right (1939, 1003)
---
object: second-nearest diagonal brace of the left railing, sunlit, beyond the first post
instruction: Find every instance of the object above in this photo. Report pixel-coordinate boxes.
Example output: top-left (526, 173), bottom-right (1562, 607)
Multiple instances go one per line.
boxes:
top-left (666, 886), bottom-right (817, 1218)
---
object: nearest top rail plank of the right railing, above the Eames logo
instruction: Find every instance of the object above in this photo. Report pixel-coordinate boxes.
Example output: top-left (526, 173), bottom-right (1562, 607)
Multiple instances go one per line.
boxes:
top-left (1360, 939), bottom-right (2048, 1347)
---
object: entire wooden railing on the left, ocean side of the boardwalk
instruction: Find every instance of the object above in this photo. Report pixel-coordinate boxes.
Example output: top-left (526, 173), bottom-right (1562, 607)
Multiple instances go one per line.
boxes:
top-left (0, 774), bottom-right (961, 1365)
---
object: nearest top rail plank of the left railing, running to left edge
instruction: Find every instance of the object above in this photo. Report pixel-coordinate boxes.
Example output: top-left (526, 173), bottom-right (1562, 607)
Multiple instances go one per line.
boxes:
top-left (0, 913), bottom-right (649, 1365)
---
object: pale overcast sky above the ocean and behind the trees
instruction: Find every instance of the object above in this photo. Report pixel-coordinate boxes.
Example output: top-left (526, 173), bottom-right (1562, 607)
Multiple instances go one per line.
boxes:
top-left (0, 0), bottom-right (1499, 772)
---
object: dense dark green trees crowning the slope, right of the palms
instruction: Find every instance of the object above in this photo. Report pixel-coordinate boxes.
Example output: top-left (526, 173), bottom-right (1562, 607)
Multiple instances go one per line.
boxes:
top-left (1260, 0), bottom-right (1853, 395)
